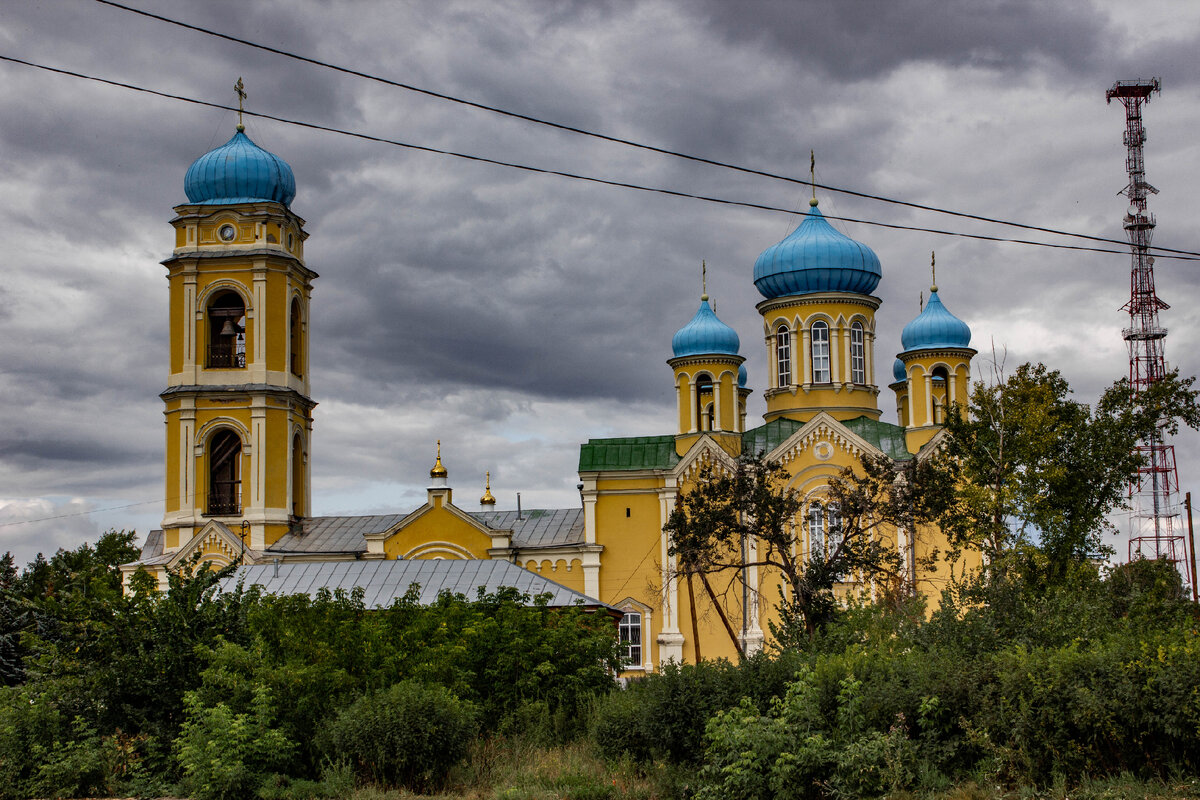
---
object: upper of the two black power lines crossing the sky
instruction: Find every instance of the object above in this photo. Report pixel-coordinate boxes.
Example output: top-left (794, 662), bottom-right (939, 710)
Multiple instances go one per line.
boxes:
top-left (96, 0), bottom-right (1196, 255)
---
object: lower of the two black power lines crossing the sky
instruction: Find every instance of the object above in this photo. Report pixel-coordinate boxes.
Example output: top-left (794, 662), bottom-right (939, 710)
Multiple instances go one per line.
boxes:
top-left (0, 55), bottom-right (1200, 261)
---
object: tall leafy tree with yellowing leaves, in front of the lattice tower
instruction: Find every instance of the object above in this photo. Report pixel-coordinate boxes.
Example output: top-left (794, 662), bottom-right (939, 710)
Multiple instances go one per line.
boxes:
top-left (936, 363), bottom-right (1200, 578)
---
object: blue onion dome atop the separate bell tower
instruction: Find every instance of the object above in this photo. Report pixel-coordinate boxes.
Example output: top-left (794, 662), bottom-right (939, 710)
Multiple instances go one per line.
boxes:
top-left (184, 126), bottom-right (296, 205)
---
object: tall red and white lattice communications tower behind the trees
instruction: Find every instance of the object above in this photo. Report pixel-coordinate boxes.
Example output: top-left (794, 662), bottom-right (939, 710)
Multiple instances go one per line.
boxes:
top-left (1105, 78), bottom-right (1190, 583)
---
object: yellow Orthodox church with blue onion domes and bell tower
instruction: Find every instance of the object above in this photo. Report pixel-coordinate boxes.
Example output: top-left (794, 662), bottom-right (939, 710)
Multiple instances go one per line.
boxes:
top-left (122, 125), bottom-right (976, 674)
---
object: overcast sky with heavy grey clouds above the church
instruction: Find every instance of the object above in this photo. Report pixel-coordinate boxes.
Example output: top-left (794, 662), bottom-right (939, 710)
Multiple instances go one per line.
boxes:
top-left (0, 0), bottom-right (1200, 561)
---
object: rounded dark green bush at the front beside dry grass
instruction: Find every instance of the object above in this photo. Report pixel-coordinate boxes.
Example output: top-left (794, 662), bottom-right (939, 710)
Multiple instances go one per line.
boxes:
top-left (326, 681), bottom-right (479, 790)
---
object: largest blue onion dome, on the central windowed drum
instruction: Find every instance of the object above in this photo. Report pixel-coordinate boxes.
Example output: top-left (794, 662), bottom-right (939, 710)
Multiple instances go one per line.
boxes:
top-left (754, 198), bottom-right (883, 300)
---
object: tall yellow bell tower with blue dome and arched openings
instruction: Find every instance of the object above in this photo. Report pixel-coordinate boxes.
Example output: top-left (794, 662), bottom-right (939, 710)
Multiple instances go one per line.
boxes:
top-left (161, 87), bottom-right (317, 552)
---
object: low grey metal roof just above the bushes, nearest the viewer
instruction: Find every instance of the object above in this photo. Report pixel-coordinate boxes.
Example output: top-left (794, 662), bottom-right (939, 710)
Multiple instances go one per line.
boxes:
top-left (220, 561), bottom-right (605, 608)
